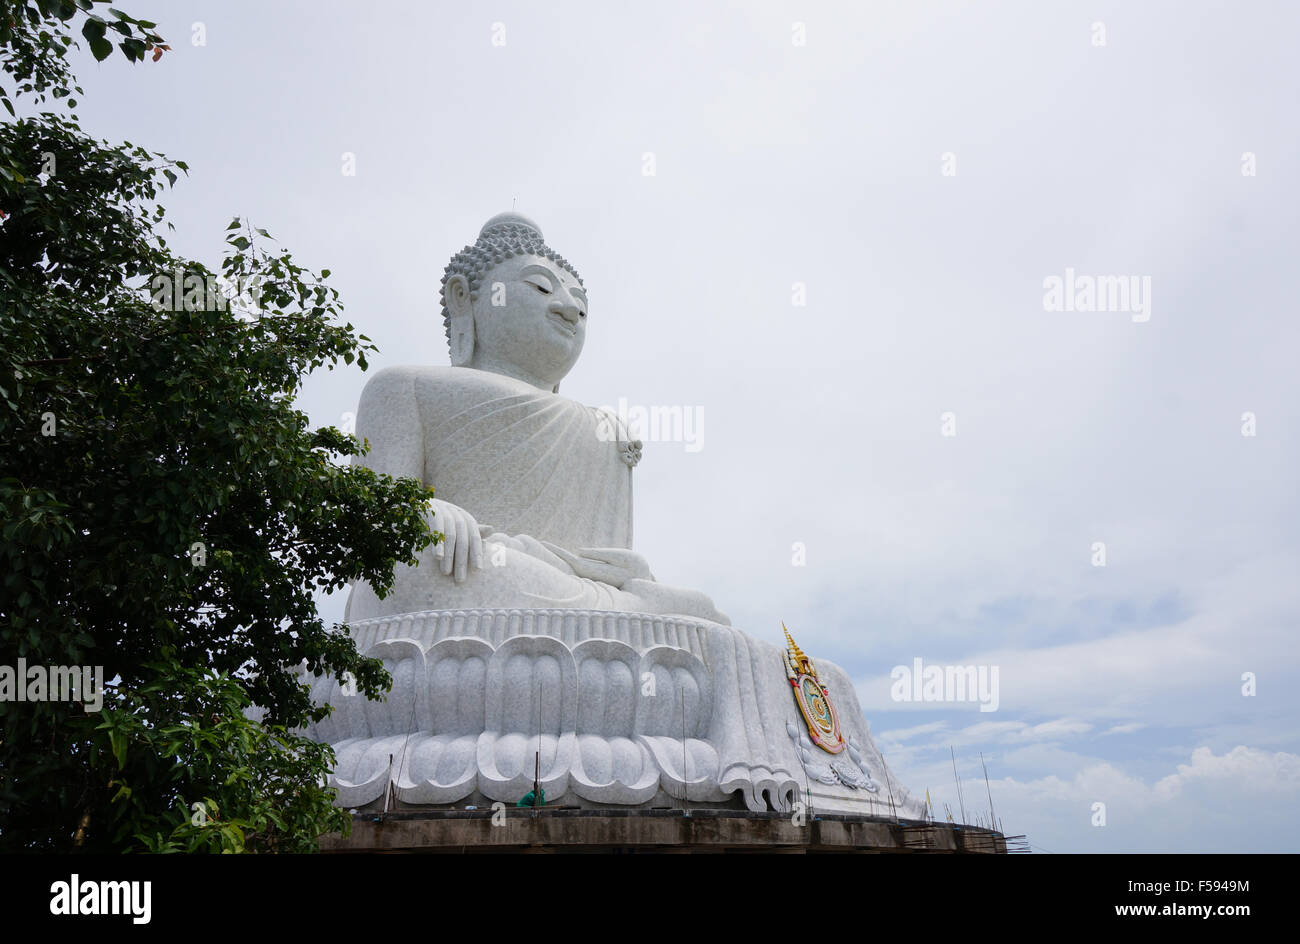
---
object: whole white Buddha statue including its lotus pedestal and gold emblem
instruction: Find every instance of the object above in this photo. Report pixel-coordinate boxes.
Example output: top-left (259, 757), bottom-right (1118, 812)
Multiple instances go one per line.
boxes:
top-left (304, 213), bottom-right (920, 815)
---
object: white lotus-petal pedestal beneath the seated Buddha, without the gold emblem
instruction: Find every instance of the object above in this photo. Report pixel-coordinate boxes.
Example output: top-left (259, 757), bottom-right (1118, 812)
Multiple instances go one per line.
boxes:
top-left (297, 609), bottom-right (923, 818)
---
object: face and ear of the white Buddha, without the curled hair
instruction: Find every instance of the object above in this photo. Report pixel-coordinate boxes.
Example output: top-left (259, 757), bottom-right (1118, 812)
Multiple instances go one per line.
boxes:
top-left (449, 255), bottom-right (586, 390)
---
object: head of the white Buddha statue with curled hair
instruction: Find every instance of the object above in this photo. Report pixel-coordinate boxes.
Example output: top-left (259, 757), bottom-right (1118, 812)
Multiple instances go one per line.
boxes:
top-left (442, 213), bottom-right (586, 391)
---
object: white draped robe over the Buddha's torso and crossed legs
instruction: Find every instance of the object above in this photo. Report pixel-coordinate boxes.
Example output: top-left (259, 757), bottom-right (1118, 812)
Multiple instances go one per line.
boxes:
top-left (346, 368), bottom-right (729, 624)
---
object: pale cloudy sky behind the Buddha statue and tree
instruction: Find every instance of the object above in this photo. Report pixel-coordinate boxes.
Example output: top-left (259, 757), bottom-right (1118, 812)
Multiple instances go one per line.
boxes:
top-left (50, 0), bottom-right (1300, 853)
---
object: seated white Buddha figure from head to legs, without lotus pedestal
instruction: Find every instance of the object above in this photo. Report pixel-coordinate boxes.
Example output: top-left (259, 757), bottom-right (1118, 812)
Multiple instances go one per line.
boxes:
top-left (346, 213), bottom-right (729, 624)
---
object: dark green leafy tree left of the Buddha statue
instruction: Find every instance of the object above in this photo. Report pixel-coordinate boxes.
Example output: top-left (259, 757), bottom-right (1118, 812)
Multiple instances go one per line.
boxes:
top-left (0, 0), bottom-right (438, 850)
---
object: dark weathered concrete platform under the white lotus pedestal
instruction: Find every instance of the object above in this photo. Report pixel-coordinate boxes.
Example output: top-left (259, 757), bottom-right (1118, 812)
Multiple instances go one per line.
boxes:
top-left (321, 809), bottom-right (1006, 854)
